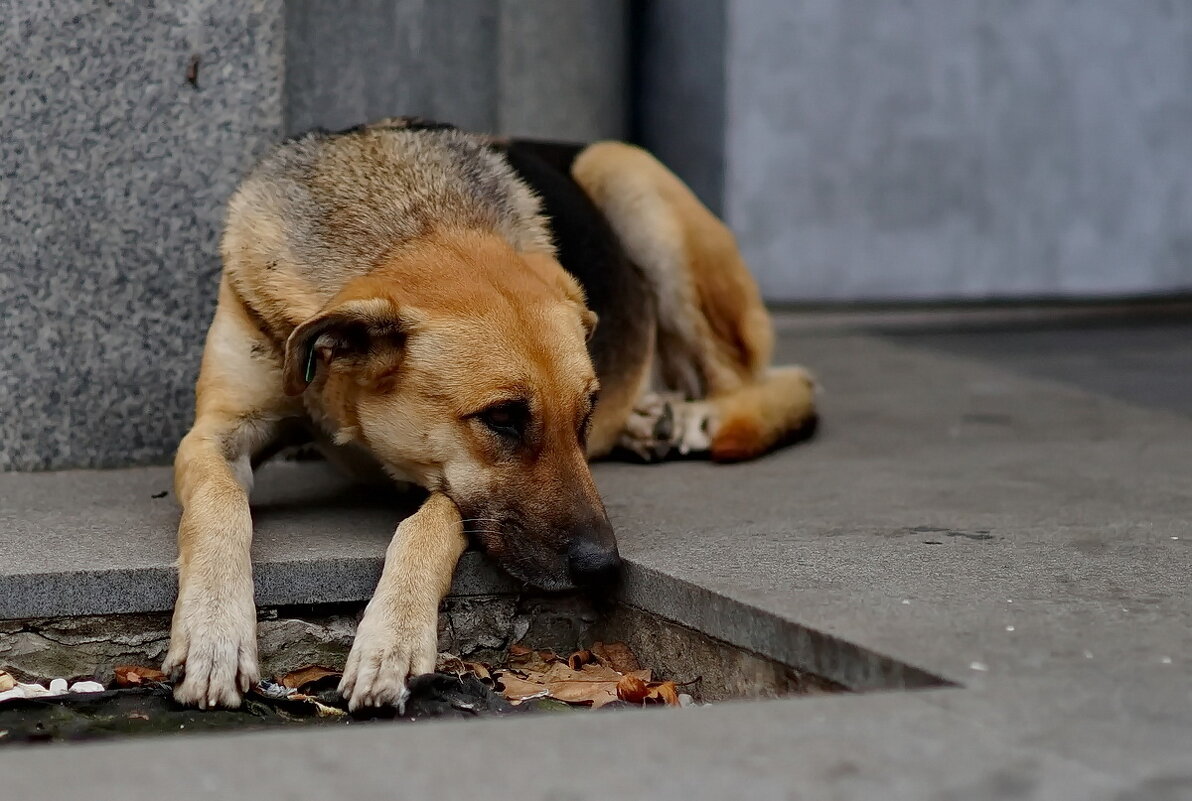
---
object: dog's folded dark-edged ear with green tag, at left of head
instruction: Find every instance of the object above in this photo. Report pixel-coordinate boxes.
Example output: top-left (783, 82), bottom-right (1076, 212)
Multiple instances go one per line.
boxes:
top-left (283, 298), bottom-right (409, 395)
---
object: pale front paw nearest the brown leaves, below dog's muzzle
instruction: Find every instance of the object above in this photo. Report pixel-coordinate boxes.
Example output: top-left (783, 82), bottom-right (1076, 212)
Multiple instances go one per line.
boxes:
top-left (340, 598), bottom-right (439, 712)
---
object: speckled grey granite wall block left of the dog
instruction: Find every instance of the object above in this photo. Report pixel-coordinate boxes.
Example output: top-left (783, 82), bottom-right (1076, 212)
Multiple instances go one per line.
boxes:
top-left (0, 0), bottom-right (283, 470)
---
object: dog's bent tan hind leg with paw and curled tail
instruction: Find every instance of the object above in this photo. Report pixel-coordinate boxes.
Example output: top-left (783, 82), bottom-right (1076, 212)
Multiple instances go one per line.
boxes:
top-left (572, 142), bottom-right (815, 461)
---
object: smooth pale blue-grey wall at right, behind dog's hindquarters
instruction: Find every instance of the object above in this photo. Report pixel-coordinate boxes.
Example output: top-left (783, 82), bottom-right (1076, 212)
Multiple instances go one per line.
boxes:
top-left (646, 0), bottom-right (1192, 300)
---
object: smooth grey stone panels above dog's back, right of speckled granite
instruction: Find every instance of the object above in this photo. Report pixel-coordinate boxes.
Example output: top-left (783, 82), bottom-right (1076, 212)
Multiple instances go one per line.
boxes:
top-left (286, 0), bottom-right (627, 141)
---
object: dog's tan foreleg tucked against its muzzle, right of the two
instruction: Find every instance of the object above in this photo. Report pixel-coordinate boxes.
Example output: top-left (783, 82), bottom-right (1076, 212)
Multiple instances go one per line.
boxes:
top-left (340, 492), bottom-right (467, 709)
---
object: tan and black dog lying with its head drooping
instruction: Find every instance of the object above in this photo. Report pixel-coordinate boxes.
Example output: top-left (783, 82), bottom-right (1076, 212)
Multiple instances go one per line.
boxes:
top-left (163, 118), bottom-right (817, 709)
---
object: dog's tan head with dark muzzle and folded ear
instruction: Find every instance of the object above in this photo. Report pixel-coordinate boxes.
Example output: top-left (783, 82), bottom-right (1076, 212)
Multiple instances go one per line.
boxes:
top-left (278, 228), bottom-right (619, 589)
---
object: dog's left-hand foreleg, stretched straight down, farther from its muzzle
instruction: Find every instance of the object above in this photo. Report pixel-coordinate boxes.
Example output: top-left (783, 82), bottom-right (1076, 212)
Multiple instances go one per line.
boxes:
top-left (162, 276), bottom-right (294, 707)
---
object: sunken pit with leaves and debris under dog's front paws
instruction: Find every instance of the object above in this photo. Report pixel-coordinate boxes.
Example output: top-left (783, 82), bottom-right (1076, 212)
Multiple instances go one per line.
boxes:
top-left (0, 595), bottom-right (949, 747)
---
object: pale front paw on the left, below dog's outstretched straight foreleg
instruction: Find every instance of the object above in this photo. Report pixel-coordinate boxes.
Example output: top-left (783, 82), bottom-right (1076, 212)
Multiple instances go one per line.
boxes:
top-left (161, 588), bottom-right (260, 709)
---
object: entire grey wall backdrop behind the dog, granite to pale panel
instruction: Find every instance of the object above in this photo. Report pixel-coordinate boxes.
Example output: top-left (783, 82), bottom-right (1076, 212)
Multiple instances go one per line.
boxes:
top-left (0, 0), bottom-right (1192, 470)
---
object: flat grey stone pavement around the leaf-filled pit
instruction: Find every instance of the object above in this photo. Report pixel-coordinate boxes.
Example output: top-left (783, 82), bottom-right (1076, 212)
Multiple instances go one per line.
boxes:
top-left (0, 319), bottom-right (1192, 801)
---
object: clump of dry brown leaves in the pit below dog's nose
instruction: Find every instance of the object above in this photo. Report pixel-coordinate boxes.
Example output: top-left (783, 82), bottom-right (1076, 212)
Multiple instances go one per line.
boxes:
top-left (495, 642), bottom-right (679, 709)
